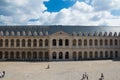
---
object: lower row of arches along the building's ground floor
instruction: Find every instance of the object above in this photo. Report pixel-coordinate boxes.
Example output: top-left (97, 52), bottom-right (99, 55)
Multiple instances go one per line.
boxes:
top-left (0, 49), bottom-right (120, 61)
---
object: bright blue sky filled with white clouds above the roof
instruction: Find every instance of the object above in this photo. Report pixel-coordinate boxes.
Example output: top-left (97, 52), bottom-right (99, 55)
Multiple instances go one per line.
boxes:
top-left (0, 0), bottom-right (120, 26)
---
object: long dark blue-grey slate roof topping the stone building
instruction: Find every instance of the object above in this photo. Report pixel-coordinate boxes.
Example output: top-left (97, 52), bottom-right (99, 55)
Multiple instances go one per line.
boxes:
top-left (0, 25), bottom-right (120, 35)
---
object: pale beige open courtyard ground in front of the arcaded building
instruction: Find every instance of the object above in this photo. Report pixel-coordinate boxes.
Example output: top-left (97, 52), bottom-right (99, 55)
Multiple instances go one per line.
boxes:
top-left (0, 60), bottom-right (120, 80)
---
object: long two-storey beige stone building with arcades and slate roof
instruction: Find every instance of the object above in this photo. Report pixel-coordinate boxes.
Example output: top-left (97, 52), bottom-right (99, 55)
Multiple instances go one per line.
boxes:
top-left (0, 25), bottom-right (120, 61)
